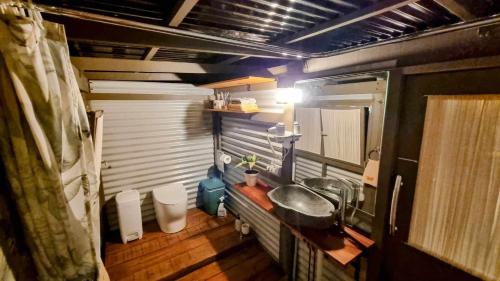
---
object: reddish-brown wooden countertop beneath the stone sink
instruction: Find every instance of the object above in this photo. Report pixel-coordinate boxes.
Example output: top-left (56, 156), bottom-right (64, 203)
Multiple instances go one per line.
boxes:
top-left (234, 182), bottom-right (375, 266)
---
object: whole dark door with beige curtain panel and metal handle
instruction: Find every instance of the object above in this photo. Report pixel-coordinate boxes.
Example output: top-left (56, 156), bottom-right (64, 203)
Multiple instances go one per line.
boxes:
top-left (381, 69), bottom-right (500, 281)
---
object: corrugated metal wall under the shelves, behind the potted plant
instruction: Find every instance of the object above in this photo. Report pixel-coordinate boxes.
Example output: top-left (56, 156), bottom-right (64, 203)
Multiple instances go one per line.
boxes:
top-left (218, 87), bottom-right (290, 260)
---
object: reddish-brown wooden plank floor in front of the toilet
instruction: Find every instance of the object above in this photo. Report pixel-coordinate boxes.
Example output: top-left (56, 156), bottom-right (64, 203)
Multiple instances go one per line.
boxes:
top-left (104, 209), bottom-right (286, 281)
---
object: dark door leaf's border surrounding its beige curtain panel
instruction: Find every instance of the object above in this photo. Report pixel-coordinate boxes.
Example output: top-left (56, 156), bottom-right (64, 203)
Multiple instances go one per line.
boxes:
top-left (386, 67), bottom-right (500, 281)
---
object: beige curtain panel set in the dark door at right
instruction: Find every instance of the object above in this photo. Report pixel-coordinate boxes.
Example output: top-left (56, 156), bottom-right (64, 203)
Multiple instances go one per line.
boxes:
top-left (408, 95), bottom-right (500, 280)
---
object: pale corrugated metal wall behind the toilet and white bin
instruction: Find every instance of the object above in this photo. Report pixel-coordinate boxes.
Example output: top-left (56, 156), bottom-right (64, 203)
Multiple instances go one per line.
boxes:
top-left (90, 80), bottom-right (214, 229)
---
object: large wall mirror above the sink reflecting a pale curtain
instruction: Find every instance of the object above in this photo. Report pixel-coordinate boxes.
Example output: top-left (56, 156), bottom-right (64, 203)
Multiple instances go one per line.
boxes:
top-left (295, 72), bottom-right (388, 232)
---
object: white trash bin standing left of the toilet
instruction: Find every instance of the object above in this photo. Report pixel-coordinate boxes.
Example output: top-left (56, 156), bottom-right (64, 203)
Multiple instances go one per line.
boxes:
top-left (116, 189), bottom-right (142, 244)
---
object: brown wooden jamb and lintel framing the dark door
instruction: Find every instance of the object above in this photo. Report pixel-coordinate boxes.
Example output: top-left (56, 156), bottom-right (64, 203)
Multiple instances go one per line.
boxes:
top-left (367, 56), bottom-right (500, 281)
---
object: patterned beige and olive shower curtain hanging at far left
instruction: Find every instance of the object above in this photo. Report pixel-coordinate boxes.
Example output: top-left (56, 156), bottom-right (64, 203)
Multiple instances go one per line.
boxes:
top-left (0, 7), bottom-right (104, 280)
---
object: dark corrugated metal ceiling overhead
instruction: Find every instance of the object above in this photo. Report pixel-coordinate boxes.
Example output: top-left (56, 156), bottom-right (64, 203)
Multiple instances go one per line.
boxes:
top-left (36, 0), bottom-right (500, 63)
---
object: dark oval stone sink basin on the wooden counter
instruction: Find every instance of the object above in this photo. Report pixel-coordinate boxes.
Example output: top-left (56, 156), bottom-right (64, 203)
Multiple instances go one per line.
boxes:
top-left (267, 184), bottom-right (335, 229)
